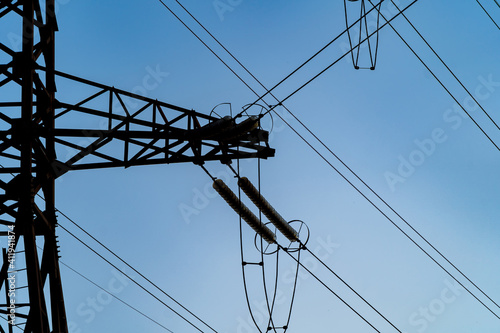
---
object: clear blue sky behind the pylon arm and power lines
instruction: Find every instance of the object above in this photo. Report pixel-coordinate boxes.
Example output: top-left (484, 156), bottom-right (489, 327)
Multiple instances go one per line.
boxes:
top-left (8, 0), bottom-right (500, 333)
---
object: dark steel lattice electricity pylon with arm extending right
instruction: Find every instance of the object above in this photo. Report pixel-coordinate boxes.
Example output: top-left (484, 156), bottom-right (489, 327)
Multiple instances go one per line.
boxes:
top-left (0, 0), bottom-right (274, 333)
